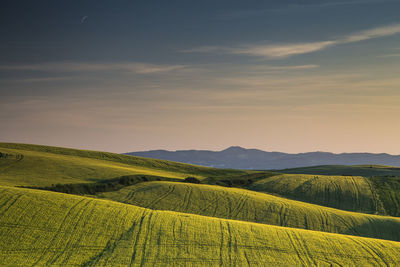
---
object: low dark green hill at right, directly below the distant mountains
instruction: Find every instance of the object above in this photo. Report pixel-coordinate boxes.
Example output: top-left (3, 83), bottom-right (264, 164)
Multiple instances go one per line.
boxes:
top-left (279, 165), bottom-right (400, 177)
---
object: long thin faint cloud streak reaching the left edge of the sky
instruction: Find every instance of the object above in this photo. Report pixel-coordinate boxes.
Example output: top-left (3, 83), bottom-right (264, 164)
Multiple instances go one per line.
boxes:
top-left (0, 62), bottom-right (186, 74)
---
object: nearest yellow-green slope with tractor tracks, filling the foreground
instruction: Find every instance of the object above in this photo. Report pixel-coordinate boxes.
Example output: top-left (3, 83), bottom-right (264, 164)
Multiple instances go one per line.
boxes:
top-left (0, 187), bottom-right (400, 266)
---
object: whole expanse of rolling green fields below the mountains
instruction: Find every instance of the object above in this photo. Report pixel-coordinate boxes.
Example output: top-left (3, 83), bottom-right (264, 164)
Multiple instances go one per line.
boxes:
top-left (0, 143), bottom-right (400, 266)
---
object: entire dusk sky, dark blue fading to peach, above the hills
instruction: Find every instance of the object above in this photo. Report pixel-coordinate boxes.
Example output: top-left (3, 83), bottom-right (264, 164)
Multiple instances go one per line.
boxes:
top-left (0, 0), bottom-right (400, 154)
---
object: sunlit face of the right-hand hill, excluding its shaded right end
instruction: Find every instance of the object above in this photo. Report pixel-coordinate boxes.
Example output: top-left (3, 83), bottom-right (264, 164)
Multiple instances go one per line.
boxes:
top-left (245, 174), bottom-right (384, 214)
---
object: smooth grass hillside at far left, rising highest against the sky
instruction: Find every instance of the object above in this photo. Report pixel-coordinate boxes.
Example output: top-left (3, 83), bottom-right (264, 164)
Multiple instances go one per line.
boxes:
top-left (0, 143), bottom-right (248, 186)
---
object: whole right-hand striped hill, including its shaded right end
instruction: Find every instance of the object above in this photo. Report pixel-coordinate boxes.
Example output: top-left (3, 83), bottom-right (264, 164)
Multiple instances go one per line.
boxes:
top-left (247, 173), bottom-right (400, 217)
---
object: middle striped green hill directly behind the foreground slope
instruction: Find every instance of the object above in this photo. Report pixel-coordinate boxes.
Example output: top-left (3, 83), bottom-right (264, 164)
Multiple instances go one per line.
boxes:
top-left (100, 182), bottom-right (400, 241)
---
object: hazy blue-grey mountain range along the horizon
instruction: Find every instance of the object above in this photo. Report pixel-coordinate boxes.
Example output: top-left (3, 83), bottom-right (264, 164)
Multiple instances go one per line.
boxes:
top-left (126, 146), bottom-right (400, 170)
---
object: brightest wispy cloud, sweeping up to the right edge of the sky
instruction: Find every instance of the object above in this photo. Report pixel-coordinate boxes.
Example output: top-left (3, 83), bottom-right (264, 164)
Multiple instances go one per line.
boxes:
top-left (182, 24), bottom-right (400, 58)
